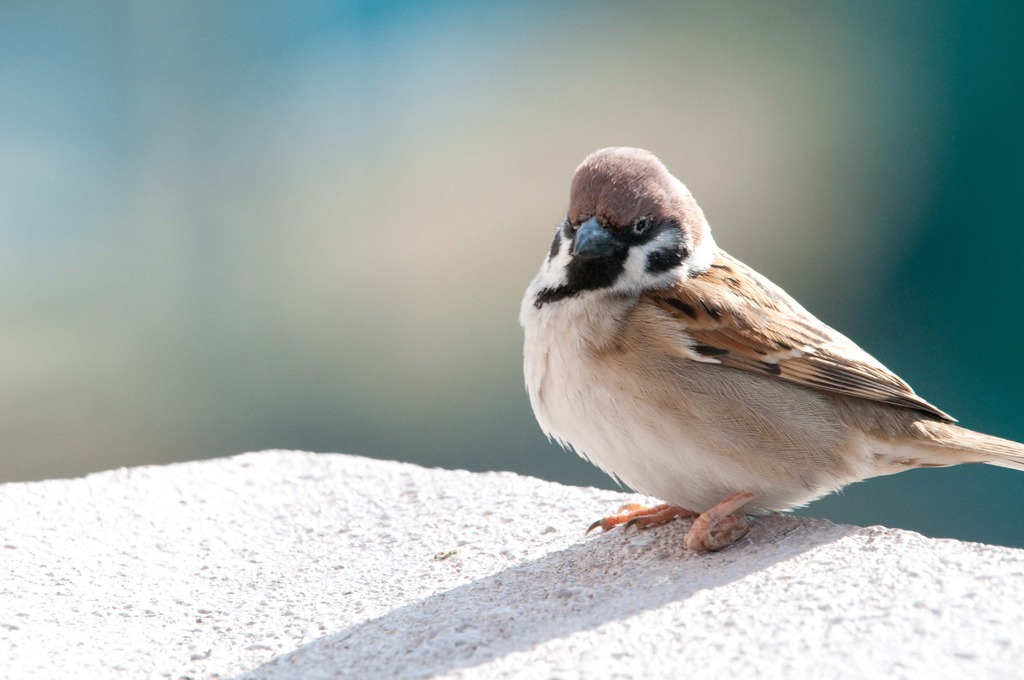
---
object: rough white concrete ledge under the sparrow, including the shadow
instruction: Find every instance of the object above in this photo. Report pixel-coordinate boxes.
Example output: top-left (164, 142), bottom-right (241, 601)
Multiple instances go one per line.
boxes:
top-left (0, 452), bottom-right (1024, 679)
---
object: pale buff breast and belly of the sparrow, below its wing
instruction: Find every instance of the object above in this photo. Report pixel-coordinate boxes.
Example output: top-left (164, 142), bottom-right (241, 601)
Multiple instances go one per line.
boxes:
top-left (523, 290), bottom-right (864, 511)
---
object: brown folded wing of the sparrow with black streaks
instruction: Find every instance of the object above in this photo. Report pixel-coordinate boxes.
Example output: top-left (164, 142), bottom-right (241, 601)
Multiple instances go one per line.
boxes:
top-left (646, 251), bottom-right (955, 422)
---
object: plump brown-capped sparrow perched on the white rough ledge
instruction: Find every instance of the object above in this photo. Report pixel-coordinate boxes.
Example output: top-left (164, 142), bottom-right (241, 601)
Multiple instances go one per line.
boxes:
top-left (519, 146), bottom-right (1024, 552)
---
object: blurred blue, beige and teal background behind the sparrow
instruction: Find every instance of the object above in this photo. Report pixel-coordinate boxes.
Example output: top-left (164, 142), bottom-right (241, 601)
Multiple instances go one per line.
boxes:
top-left (0, 0), bottom-right (1024, 546)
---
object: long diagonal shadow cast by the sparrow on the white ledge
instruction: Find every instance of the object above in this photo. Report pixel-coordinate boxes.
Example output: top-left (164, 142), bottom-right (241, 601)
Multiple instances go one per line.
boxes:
top-left (240, 515), bottom-right (859, 680)
